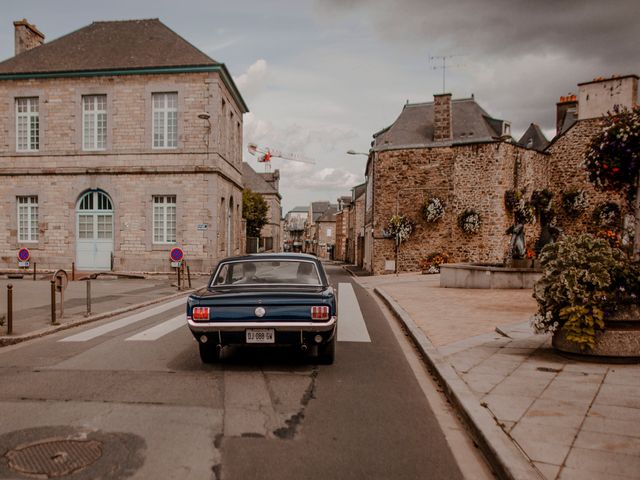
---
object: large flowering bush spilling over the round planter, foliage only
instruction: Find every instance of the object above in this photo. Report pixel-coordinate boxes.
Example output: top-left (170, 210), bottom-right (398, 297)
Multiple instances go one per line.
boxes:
top-left (531, 234), bottom-right (640, 349)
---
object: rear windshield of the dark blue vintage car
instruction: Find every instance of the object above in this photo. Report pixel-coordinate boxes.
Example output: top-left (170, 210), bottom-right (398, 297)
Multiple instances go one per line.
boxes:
top-left (210, 260), bottom-right (322, 287)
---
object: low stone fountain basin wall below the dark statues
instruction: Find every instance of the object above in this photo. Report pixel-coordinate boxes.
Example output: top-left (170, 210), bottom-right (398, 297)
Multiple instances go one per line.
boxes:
top-left (440, 263), bottom-right (542, 289)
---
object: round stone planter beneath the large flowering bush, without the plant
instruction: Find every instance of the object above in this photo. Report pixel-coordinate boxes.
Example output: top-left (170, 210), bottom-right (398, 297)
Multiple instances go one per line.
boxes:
top-left (552, 305), bottom-right (640, 360)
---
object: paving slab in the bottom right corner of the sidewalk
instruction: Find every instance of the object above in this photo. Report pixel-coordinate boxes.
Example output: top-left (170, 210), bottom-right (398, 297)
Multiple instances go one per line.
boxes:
top-left (561, 448), bottom-right (640, 478)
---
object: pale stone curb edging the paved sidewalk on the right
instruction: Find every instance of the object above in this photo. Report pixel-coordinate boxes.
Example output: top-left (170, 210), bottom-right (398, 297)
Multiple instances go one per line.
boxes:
top-left (373, 288), bottom-right (544, 480)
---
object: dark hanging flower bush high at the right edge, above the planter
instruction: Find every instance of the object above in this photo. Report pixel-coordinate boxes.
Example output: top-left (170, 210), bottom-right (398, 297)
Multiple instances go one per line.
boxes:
top-left (584, 106), bottom-right (640, 203)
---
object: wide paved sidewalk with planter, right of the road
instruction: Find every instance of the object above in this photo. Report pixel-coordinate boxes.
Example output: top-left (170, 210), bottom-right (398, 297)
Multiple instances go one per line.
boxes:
top-left (357, 274), bottom-right (640, 480)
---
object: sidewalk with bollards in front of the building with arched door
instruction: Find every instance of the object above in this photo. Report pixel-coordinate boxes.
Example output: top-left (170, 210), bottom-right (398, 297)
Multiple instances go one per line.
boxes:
top-left (0, 276), bottom-right (208, 346)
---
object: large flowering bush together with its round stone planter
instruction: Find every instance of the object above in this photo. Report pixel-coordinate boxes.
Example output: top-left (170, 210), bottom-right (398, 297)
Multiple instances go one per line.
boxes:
top-left (531, 234), bottom-right (640, 356)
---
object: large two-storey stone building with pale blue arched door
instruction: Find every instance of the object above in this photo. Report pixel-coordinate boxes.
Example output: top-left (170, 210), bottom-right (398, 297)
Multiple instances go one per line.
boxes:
top-left (0, 19), bottom-right (248, 271)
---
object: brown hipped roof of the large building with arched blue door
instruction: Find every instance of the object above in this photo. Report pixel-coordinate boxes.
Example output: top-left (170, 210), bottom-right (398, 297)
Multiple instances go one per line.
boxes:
top-left (0, 18), bottom-right (220, 74)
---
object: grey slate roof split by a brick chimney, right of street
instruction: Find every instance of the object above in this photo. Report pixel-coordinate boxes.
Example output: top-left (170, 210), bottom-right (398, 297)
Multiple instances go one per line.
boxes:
top-left (373, 98), bottom-right (503, 150)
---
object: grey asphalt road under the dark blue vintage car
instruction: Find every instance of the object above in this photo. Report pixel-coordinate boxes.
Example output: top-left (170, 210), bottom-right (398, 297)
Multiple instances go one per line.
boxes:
top-left (0, 267), bottom-right (476, 480)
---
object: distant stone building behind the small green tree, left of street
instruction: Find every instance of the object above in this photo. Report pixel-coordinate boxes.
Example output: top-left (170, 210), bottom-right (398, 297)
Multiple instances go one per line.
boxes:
top-left (242, 162), bottom-right (282, 252)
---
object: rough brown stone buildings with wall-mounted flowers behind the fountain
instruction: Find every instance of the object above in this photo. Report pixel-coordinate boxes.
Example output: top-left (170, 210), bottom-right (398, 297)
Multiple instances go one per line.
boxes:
top-left (363, 75), bottom-right (638, 274)
